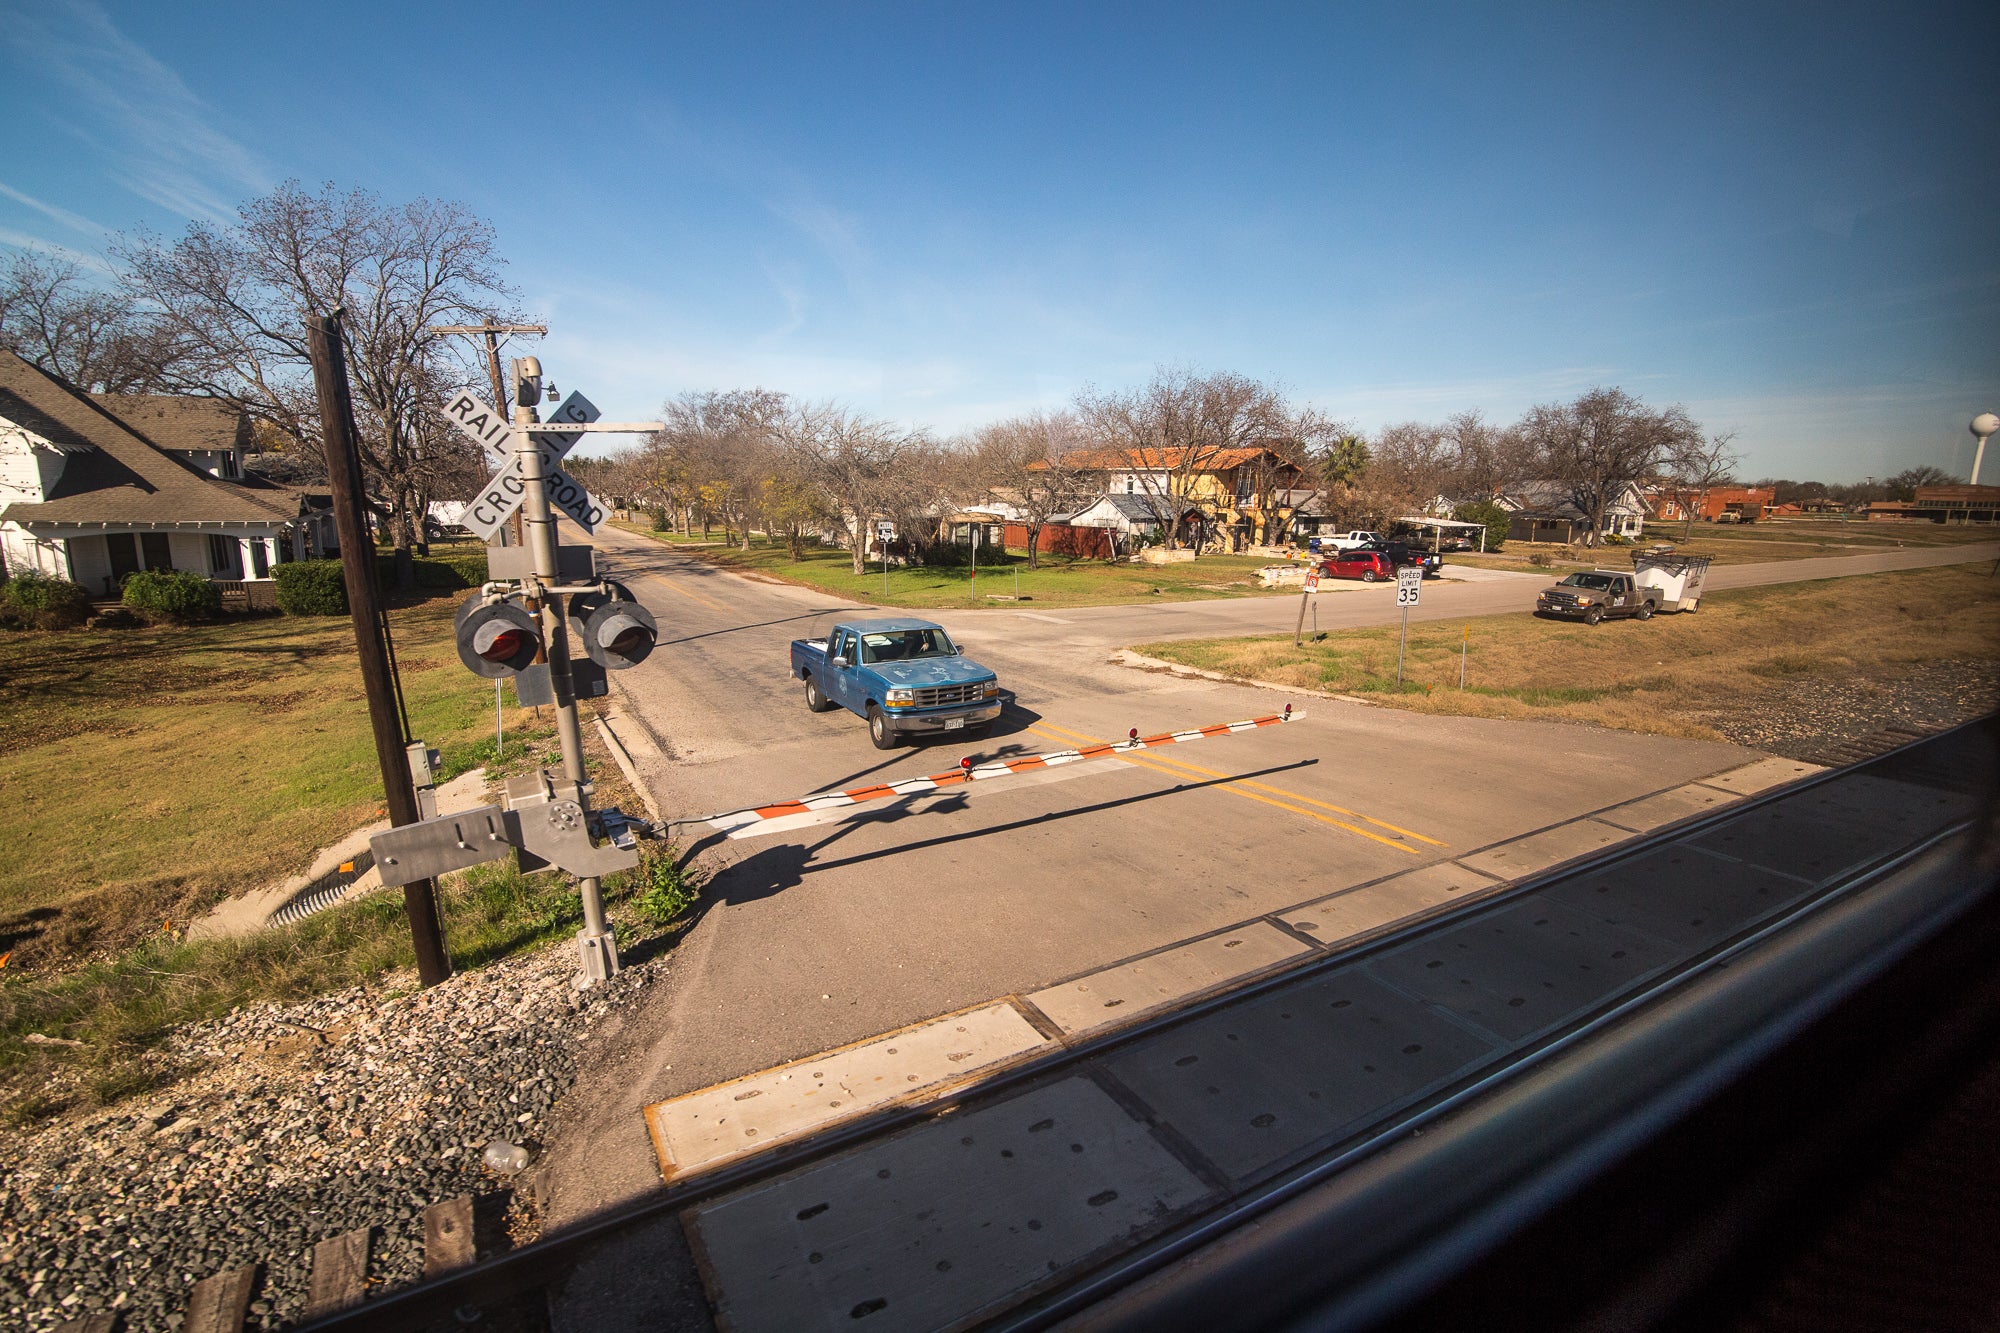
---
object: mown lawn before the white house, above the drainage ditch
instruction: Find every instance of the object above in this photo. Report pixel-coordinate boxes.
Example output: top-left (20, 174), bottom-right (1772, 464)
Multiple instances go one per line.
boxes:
top-left (0, 596), bottom-right (516, 967)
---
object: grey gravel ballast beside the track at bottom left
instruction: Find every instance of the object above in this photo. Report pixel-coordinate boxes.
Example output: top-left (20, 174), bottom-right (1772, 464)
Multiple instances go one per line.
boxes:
top-left (0, 943), bottom-right (664, 1331)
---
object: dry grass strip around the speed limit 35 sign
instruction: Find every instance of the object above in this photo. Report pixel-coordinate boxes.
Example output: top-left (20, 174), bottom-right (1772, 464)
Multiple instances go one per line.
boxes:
top-left (1136, 566), bottom-right (2000, 739)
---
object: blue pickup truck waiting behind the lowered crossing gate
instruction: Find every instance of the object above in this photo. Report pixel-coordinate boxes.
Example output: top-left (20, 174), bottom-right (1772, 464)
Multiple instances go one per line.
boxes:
top-left (792, 620), bottom-right (1000, 751)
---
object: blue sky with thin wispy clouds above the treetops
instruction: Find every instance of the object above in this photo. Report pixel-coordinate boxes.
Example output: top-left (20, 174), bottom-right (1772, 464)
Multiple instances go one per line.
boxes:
top-left (0, 0), bottom-right (2000, 480)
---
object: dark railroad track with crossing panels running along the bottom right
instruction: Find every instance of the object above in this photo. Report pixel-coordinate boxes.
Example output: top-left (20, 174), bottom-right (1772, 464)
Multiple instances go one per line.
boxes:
top-left (137, 717), bottom-right (2000, 1333)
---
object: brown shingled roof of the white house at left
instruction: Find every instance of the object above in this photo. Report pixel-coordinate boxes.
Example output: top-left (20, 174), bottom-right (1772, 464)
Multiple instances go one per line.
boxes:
top-left (0, 352), bottom-right (298, 524)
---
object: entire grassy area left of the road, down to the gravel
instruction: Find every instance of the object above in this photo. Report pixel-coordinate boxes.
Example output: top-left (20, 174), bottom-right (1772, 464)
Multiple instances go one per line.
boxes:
top-left (0, 556), bottom-right (704, 1123)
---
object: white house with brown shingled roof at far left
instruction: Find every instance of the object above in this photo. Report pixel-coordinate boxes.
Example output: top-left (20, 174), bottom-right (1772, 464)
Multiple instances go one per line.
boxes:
top-left (0, 352), bottom-right (334, 606)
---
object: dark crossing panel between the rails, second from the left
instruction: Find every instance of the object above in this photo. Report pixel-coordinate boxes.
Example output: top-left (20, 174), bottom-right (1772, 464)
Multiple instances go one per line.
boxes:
top-left (1104, 967), bottom-right (1498, 1183)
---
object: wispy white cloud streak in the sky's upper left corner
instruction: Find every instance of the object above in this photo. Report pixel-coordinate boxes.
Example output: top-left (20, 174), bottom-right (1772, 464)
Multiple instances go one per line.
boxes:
top-left (0, 0), bottom-right (272, 222)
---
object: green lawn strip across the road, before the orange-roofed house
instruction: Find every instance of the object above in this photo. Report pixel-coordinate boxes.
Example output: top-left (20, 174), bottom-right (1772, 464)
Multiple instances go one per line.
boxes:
top-left (618, 522), bottom-right (1296, 610)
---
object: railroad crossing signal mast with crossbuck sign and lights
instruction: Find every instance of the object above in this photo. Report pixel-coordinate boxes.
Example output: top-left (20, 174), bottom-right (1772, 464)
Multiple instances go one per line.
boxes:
top-left (370, 356), bottom-right (680, 989)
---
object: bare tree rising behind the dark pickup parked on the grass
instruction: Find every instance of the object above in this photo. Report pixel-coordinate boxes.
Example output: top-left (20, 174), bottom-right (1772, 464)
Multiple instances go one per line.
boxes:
top-left (1520, 388), bottom-right (1702, 546)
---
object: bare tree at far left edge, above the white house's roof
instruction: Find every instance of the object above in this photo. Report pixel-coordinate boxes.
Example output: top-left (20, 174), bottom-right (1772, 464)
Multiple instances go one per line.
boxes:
top-left (0, 250), bottom-right (178, 394)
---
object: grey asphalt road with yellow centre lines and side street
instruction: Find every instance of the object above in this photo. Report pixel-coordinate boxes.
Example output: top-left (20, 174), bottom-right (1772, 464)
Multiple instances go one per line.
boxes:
top-left (532, 532), bottom-right (2000, 1225)
